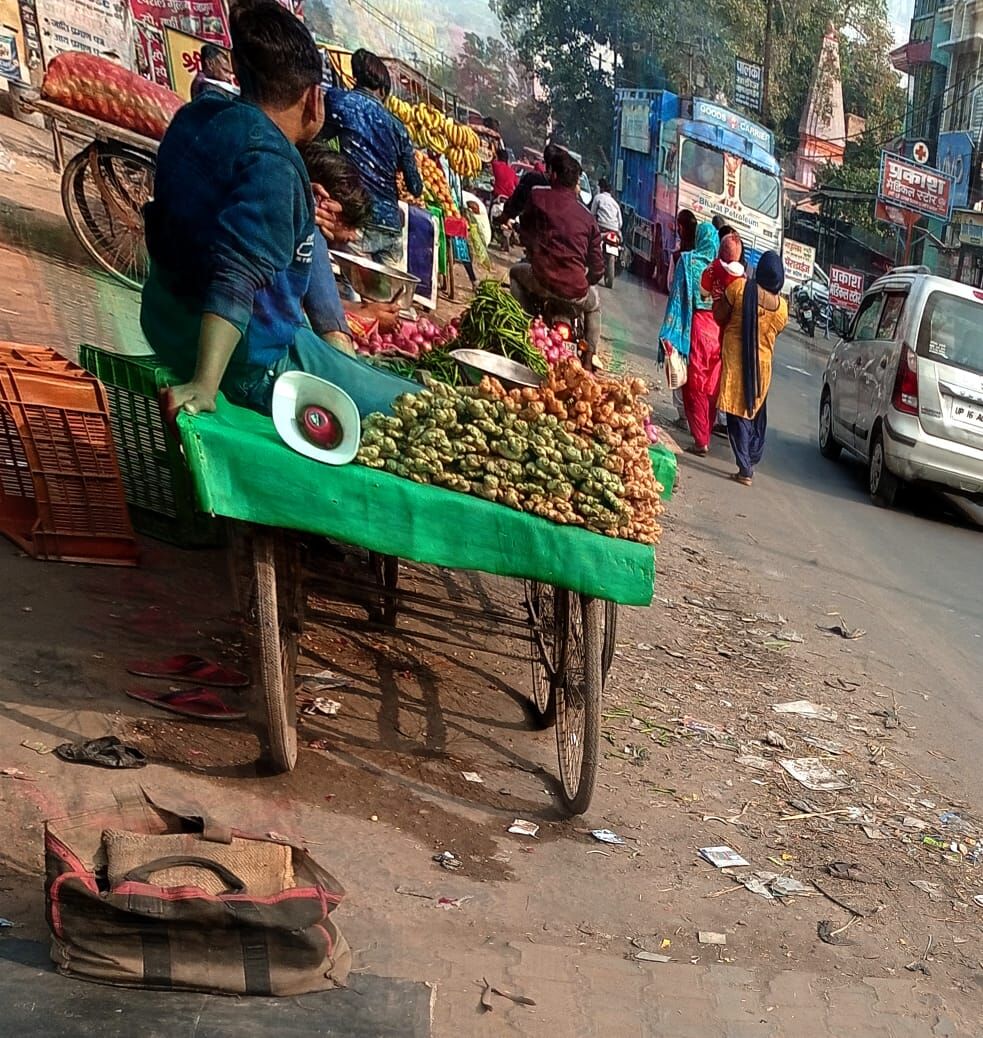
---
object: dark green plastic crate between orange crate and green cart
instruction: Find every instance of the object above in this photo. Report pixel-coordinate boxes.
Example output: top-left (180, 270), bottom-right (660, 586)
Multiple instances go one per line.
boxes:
top-left (79, 346), bottom-right (224, 548)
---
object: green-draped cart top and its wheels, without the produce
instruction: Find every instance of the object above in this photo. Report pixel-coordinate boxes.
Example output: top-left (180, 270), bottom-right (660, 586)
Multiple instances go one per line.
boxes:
top-left (179, 398), bottom-right (675, 814)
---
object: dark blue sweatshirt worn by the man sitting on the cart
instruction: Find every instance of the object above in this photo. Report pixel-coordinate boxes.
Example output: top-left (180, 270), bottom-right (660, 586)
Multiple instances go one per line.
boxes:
top-left (140, 92), bottom-right (344, 377)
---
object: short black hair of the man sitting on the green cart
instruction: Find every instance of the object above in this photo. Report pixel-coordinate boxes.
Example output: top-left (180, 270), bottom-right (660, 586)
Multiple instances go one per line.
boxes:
top-left (229, 0), bottom-right (324, 110)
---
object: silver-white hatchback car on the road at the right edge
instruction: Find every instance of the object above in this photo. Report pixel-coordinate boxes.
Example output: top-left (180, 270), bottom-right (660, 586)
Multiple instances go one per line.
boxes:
top-left (819, 267), bottom-right (983, 508)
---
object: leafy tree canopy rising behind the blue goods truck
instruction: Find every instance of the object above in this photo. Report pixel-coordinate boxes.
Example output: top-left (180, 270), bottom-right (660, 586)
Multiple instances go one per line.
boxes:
top-left (492, 0), bottom-right (904, 164)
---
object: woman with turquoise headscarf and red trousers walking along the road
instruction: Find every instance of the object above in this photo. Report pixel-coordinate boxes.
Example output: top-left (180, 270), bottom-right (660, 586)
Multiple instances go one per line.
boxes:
top-left (659, 223), bottom-right (720, 456)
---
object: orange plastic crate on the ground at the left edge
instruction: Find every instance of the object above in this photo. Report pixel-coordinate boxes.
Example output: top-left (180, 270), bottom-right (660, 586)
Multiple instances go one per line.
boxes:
top-left (0, 359), bottom-right (137, 566)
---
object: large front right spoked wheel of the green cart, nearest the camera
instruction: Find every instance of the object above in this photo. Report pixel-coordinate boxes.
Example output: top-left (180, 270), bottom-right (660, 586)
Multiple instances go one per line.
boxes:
top-left (556, 592), bottom-right (604, 815)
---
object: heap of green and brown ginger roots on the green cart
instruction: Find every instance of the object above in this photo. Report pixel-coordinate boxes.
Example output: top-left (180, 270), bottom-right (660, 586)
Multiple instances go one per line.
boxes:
top-left (357, 358), bottom-right (662, 544)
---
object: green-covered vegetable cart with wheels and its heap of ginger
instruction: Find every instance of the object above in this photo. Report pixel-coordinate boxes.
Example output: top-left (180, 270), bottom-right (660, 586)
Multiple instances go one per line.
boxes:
top-left (171, 332), bottom-right (675, 814)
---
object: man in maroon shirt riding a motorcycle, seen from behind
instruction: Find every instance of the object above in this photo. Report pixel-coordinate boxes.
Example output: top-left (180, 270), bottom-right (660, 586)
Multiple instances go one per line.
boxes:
top-left (509, 152), bottom-right (604, 356)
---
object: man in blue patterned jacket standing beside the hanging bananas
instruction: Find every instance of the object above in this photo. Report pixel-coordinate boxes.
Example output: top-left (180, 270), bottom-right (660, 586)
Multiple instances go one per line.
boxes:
top-left (322, 50), bottom-right (424, 266)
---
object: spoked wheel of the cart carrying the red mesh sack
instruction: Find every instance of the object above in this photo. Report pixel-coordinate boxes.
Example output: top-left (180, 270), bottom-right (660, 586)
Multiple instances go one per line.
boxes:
top-left (61, 141), bottom-right (156, 289)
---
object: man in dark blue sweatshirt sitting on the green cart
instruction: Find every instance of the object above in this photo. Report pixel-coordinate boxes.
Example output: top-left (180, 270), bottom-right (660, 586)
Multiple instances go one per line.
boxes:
top-left (140, 0), bottom-right (419, 419)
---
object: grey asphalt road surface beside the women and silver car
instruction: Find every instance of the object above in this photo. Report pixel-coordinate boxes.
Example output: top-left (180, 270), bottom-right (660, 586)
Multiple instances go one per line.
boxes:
top-left (603, 277), bottom-right (983, 790)
